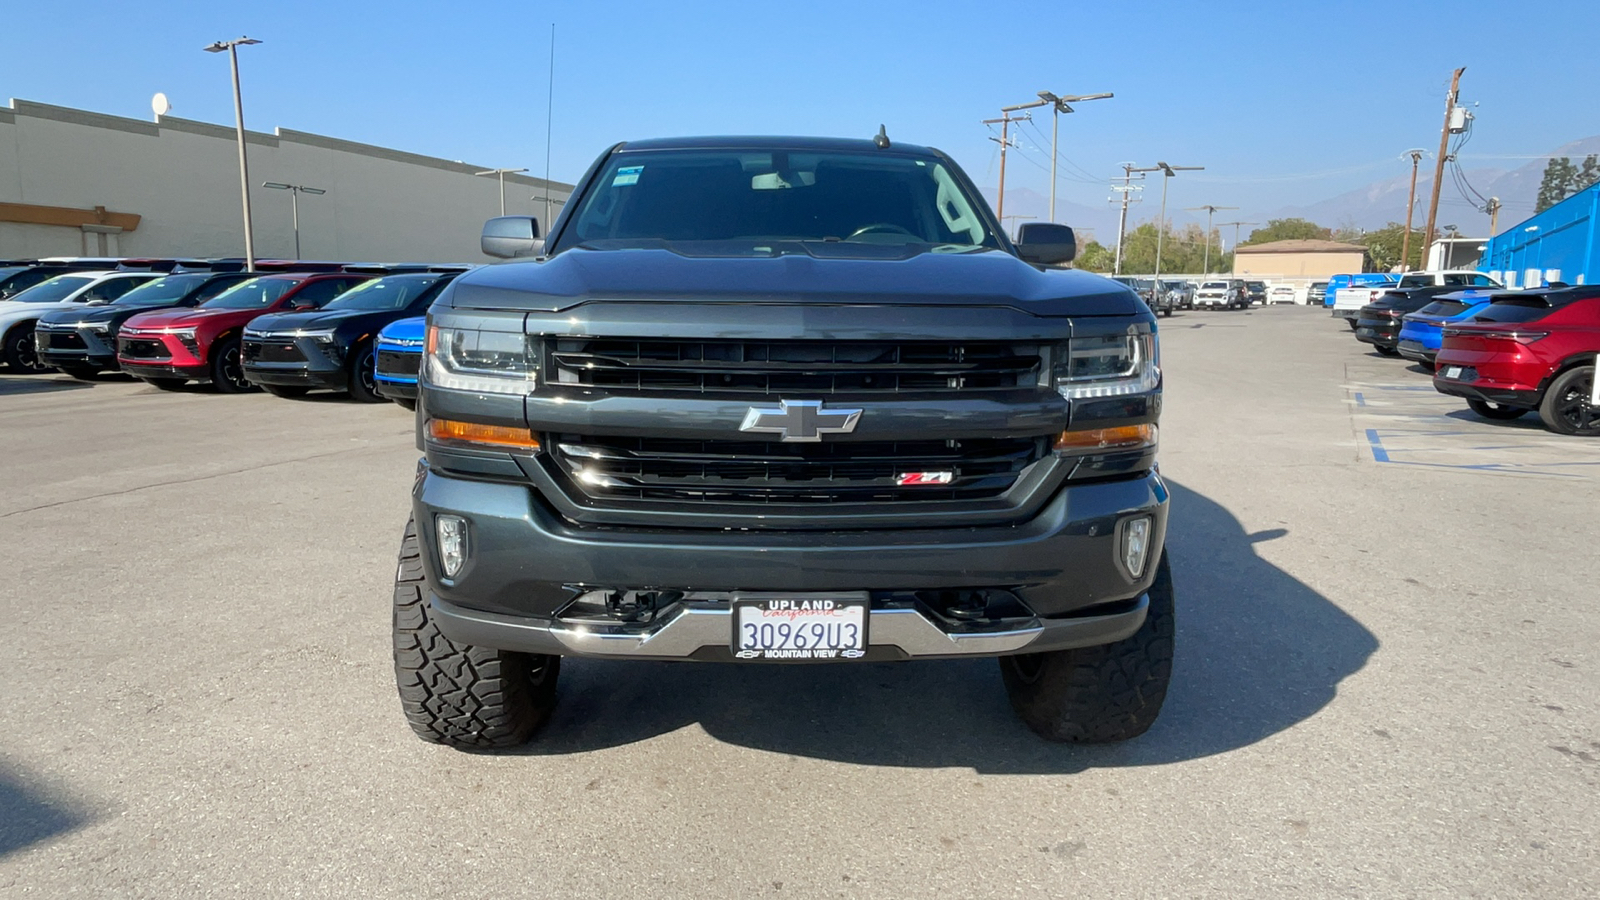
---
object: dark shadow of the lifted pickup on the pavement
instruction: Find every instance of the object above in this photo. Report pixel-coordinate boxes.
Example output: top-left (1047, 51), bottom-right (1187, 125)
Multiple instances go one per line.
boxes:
top-left (523, 482), bottom-right (1378, 773)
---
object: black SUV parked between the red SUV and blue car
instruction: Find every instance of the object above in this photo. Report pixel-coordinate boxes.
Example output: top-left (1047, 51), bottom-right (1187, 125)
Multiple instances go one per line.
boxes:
top-left (240, 266), bottom-right (466, 404)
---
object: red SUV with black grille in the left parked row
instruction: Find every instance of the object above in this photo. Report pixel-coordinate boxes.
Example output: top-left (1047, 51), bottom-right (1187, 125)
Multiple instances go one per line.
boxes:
top-left (117, 272), bottom-right (371, 394)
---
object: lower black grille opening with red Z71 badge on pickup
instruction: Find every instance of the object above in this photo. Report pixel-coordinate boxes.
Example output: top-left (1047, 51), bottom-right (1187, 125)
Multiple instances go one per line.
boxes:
top-left (549, 434), bottom-right (1050, 504)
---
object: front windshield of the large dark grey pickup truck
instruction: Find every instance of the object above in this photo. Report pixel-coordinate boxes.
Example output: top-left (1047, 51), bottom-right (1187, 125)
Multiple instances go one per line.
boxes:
top-left (568, 149), bottom-right (1000, 253)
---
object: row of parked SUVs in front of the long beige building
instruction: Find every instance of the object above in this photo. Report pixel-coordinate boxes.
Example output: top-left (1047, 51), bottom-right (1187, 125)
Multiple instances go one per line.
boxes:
top-left (0, 259), bottom-right (469, 405)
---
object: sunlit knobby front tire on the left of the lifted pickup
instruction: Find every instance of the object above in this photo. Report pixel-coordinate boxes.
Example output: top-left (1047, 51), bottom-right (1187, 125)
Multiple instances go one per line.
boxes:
top-left (394, 519), bottom-right (562, 749)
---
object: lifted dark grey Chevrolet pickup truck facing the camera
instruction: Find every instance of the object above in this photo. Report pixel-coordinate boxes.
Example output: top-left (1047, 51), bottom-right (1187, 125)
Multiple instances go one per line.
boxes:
top-left (394, 133), bottom-right (1173, 748)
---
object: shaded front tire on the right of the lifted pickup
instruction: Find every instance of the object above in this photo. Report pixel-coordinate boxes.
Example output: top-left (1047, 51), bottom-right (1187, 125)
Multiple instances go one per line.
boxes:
top-left (1000, 551), bottom-right (1173, 743)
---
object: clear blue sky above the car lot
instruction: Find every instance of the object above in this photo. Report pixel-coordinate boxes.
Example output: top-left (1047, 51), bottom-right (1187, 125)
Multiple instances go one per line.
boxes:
top-left (0, 0), bottom-right (1600, 222)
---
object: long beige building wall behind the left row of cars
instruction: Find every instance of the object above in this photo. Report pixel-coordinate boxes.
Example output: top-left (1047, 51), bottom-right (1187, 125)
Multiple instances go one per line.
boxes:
top-left (0, 99), bottom-right (573, 263)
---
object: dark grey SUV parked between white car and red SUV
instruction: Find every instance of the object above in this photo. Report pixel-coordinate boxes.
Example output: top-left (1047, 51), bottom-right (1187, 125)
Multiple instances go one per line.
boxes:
top-left (34, 263), bottom-right (256, 378)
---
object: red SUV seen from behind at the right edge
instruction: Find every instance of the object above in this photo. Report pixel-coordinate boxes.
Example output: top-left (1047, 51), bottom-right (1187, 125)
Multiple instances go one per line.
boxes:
top-left (1434, 285), bottom-right (1600, 436)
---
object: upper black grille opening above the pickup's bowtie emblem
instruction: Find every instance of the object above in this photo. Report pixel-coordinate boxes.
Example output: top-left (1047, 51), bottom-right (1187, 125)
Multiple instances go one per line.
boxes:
top-left (549, 338), bottom-right (1040, 394)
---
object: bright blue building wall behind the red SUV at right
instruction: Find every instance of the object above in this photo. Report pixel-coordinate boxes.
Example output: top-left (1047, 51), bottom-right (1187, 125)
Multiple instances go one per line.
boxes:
top-left (1478, 184), bottom-right (1600, 288)
